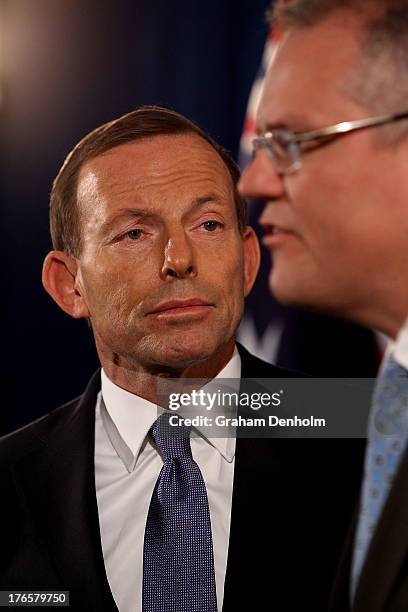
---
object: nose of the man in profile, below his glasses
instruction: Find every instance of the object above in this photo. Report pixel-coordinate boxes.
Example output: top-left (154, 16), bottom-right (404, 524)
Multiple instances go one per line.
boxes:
top-left (238, 151), bottom-right (284, 200)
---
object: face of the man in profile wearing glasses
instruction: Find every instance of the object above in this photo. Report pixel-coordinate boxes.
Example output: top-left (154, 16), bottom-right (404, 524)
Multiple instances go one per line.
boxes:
top-left (239, 13), bottom-right (408, 332)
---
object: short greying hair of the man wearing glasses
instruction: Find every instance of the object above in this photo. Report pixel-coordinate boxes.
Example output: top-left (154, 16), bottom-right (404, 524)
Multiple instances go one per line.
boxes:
top-left (269, 0), bottom-right (408, 139)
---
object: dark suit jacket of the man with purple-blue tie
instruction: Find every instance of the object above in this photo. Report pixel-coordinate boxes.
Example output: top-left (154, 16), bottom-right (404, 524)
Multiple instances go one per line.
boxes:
top-left (0, 347), bottom-right (364, 612)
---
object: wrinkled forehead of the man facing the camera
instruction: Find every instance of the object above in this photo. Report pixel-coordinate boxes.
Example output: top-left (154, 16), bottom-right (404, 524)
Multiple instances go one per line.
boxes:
top-left (77, 134), bottom-right (233, 224)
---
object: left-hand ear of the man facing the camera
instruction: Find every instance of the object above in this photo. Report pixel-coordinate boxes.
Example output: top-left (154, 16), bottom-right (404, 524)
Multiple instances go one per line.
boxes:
top-left (42, 251), bottom-right (90, 319)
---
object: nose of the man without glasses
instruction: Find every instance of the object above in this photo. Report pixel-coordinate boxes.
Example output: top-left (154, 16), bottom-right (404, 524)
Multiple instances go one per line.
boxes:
top-left (161, 229), bottom-right (197, 280)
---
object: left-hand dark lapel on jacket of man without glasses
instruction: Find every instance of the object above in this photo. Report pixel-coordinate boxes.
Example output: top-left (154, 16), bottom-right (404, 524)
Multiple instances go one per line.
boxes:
top-left (14, 373), bottom-right (117, 610)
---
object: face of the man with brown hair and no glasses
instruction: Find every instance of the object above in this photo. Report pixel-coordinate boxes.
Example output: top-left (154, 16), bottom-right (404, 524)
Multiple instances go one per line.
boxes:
top-left (73, 134), bottom-right (253, 369)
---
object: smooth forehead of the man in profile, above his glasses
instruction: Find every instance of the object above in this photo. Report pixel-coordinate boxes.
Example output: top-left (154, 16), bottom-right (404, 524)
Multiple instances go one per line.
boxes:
top-left (257, 12), bottom-right (365, 132)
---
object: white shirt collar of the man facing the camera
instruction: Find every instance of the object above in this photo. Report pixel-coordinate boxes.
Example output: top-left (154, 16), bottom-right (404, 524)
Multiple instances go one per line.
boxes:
top-left (99, 347), bottom-right (241, 472)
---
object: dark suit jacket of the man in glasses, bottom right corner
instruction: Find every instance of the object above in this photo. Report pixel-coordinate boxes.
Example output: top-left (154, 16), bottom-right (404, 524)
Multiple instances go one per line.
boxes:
top-left (330, 440), bottom-right (408, 612)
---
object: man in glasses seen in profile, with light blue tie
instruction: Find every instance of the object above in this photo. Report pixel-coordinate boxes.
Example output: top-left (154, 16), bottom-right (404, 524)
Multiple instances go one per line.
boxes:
top-left (240, 0), bottom-right (408, 612)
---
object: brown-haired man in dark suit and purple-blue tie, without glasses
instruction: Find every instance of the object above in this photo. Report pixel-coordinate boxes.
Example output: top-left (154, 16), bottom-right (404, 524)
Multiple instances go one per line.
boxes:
top-left (0, 107), bottom-right (362, 612)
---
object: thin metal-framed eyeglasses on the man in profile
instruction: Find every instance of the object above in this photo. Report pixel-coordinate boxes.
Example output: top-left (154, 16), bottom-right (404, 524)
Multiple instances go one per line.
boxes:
top-left (252, 112), bottom-right (408, 174)
